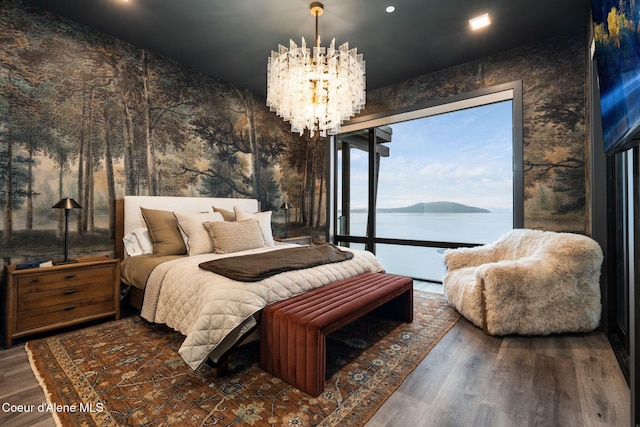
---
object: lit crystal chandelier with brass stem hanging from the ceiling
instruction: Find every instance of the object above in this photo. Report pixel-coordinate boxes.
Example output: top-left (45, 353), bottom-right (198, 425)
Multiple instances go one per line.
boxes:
top-left (267, 2), bottom-right (366, 137)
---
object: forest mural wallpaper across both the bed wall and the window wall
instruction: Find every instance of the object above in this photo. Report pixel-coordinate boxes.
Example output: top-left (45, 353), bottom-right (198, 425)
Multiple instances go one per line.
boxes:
top-left (0, 0), bottom-right (589, 268)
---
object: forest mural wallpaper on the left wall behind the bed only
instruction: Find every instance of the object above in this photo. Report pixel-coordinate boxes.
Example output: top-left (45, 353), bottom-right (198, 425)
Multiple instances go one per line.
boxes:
top-left (0, 2), bottom-right (326, 261)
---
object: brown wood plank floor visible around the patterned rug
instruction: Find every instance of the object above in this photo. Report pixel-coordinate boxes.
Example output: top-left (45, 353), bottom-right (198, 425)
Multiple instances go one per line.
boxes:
top-left (0, 284), bottom-right (630, 427)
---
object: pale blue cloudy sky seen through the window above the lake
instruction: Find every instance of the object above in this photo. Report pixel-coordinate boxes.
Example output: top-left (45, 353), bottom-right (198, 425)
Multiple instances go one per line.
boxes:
top-left (342, 101), bottom-right (513, 211)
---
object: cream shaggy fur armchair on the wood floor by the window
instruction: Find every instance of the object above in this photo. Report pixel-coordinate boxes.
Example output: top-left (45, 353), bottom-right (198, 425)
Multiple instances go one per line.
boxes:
top-left (443, 229), bottom-right (602, 335)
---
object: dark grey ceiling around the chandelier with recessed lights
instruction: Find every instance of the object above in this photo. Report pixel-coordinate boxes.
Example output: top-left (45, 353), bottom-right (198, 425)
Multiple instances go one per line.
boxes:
top-left (27, 0), bottom-right (591, 95)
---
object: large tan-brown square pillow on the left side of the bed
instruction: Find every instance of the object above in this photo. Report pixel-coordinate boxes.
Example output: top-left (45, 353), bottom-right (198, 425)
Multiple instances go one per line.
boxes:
top-left (140, 207), bottom-right (187, 256)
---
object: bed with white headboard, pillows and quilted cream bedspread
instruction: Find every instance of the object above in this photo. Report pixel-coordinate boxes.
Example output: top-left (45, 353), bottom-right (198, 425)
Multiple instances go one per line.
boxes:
top-left (115, 196), bottom-right (383, 369)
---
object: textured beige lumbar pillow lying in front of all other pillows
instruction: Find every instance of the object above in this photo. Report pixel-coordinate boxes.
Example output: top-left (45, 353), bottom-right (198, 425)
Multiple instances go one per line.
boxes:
top-left (202, 219), bottom-right (266, 254)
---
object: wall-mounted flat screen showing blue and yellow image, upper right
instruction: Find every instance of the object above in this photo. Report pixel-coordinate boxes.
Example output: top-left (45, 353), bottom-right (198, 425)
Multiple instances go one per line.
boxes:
top-left (592, 0), bottom-right (640, 154)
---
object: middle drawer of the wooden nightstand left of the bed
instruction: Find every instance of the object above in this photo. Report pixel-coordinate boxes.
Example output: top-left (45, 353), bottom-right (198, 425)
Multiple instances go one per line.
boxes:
top-left (18, 281), bottom-right (113, 315)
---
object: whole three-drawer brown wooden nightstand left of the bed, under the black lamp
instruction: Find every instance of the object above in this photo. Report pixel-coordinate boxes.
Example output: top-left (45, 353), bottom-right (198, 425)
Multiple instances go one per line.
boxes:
top-left (4, 257), bottom-right (120, 348)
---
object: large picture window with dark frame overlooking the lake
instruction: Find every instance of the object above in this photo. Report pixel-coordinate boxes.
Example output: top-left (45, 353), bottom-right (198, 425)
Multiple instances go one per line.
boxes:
top-left (332, 83), bottom-right (523, 282)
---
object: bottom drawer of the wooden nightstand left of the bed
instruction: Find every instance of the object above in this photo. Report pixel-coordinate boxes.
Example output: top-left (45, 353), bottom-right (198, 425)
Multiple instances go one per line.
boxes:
top-left (16, 295), bottom-right (115, 332)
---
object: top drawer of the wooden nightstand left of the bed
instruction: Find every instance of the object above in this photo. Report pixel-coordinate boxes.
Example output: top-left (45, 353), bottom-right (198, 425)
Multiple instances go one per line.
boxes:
top-left (17, 266), bottom-right (113, 295)
